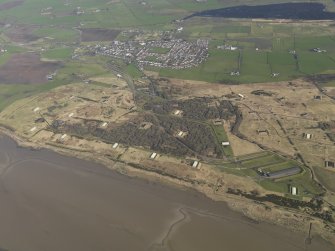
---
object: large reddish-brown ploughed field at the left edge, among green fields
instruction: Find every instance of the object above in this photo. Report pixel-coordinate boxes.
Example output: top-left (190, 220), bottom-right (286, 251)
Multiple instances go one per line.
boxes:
top-left (0, 53), bottom-right (60, 84)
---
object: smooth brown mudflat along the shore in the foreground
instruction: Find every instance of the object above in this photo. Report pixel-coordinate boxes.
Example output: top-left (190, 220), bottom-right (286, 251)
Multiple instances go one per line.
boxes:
top-left (0, 136), bottom-right (334, 251)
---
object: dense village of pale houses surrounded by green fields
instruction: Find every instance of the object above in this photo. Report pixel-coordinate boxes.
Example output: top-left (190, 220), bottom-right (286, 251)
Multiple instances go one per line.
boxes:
top-left (85, 39), bottom-right (208, 69)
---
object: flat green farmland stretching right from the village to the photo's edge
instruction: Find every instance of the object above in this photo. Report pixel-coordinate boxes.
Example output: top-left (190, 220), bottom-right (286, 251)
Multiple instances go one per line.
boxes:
top-left (151, 19), bottom-right (335, 83)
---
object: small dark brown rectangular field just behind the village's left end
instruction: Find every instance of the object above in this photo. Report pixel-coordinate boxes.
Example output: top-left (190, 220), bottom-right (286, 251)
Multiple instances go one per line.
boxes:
top-left (80, 28), bottom-right (120, 42)
